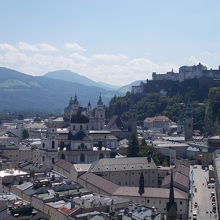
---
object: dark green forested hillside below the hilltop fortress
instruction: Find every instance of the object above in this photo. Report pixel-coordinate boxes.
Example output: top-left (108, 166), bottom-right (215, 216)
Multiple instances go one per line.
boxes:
top-left (107, 79), bottom-right (220, 133)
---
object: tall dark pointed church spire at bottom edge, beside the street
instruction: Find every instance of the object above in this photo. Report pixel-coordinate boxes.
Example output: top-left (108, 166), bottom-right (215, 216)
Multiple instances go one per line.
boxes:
top-left (167, 171), bottom-right (177, 220)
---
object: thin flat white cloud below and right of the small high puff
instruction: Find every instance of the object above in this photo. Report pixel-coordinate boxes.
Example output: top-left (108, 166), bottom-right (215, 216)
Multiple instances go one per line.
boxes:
top-left (92, 54), bottom-right (128, 62)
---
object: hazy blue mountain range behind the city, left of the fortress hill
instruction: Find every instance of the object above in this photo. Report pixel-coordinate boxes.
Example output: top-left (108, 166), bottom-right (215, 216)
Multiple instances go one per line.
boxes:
top-left (0, 67), bottom-right (141, 112)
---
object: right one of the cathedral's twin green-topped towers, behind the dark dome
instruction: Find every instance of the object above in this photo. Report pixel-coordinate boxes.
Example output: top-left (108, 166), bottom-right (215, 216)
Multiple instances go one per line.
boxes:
top-left (95, 95), bottom-right (105, 130)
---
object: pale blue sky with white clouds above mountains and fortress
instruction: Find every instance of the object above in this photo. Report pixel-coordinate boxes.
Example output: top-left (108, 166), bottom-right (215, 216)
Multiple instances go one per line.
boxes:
top-left (0, 0), bottom-right (220, 85)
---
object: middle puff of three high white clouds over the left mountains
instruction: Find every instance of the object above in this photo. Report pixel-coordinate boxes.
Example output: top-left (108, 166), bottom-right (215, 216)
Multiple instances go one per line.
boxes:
top-left (17, 42), bottom-right (57, 52)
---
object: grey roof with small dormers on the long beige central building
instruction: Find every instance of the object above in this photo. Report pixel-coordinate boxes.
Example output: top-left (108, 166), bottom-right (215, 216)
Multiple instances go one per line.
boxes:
top-left (89, 157), bottom-right (157, 172)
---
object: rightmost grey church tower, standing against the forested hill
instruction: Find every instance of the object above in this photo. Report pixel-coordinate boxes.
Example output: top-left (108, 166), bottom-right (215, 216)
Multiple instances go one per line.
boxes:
top-left (184, 105), bottom-right (193, 141)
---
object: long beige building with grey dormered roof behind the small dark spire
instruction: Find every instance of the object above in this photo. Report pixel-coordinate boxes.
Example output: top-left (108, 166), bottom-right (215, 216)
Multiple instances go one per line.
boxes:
top-left (89, 157), bottom-right (160, 187)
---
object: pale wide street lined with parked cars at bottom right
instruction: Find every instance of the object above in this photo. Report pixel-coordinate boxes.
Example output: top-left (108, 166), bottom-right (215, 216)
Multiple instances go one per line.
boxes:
top-left (189, 165), bottom-right (218, 220)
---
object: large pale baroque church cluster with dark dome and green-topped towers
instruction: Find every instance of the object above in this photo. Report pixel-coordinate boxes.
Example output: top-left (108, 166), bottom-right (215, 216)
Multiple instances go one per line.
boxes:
top-left (40, 96), bottom-right (118, 167)
